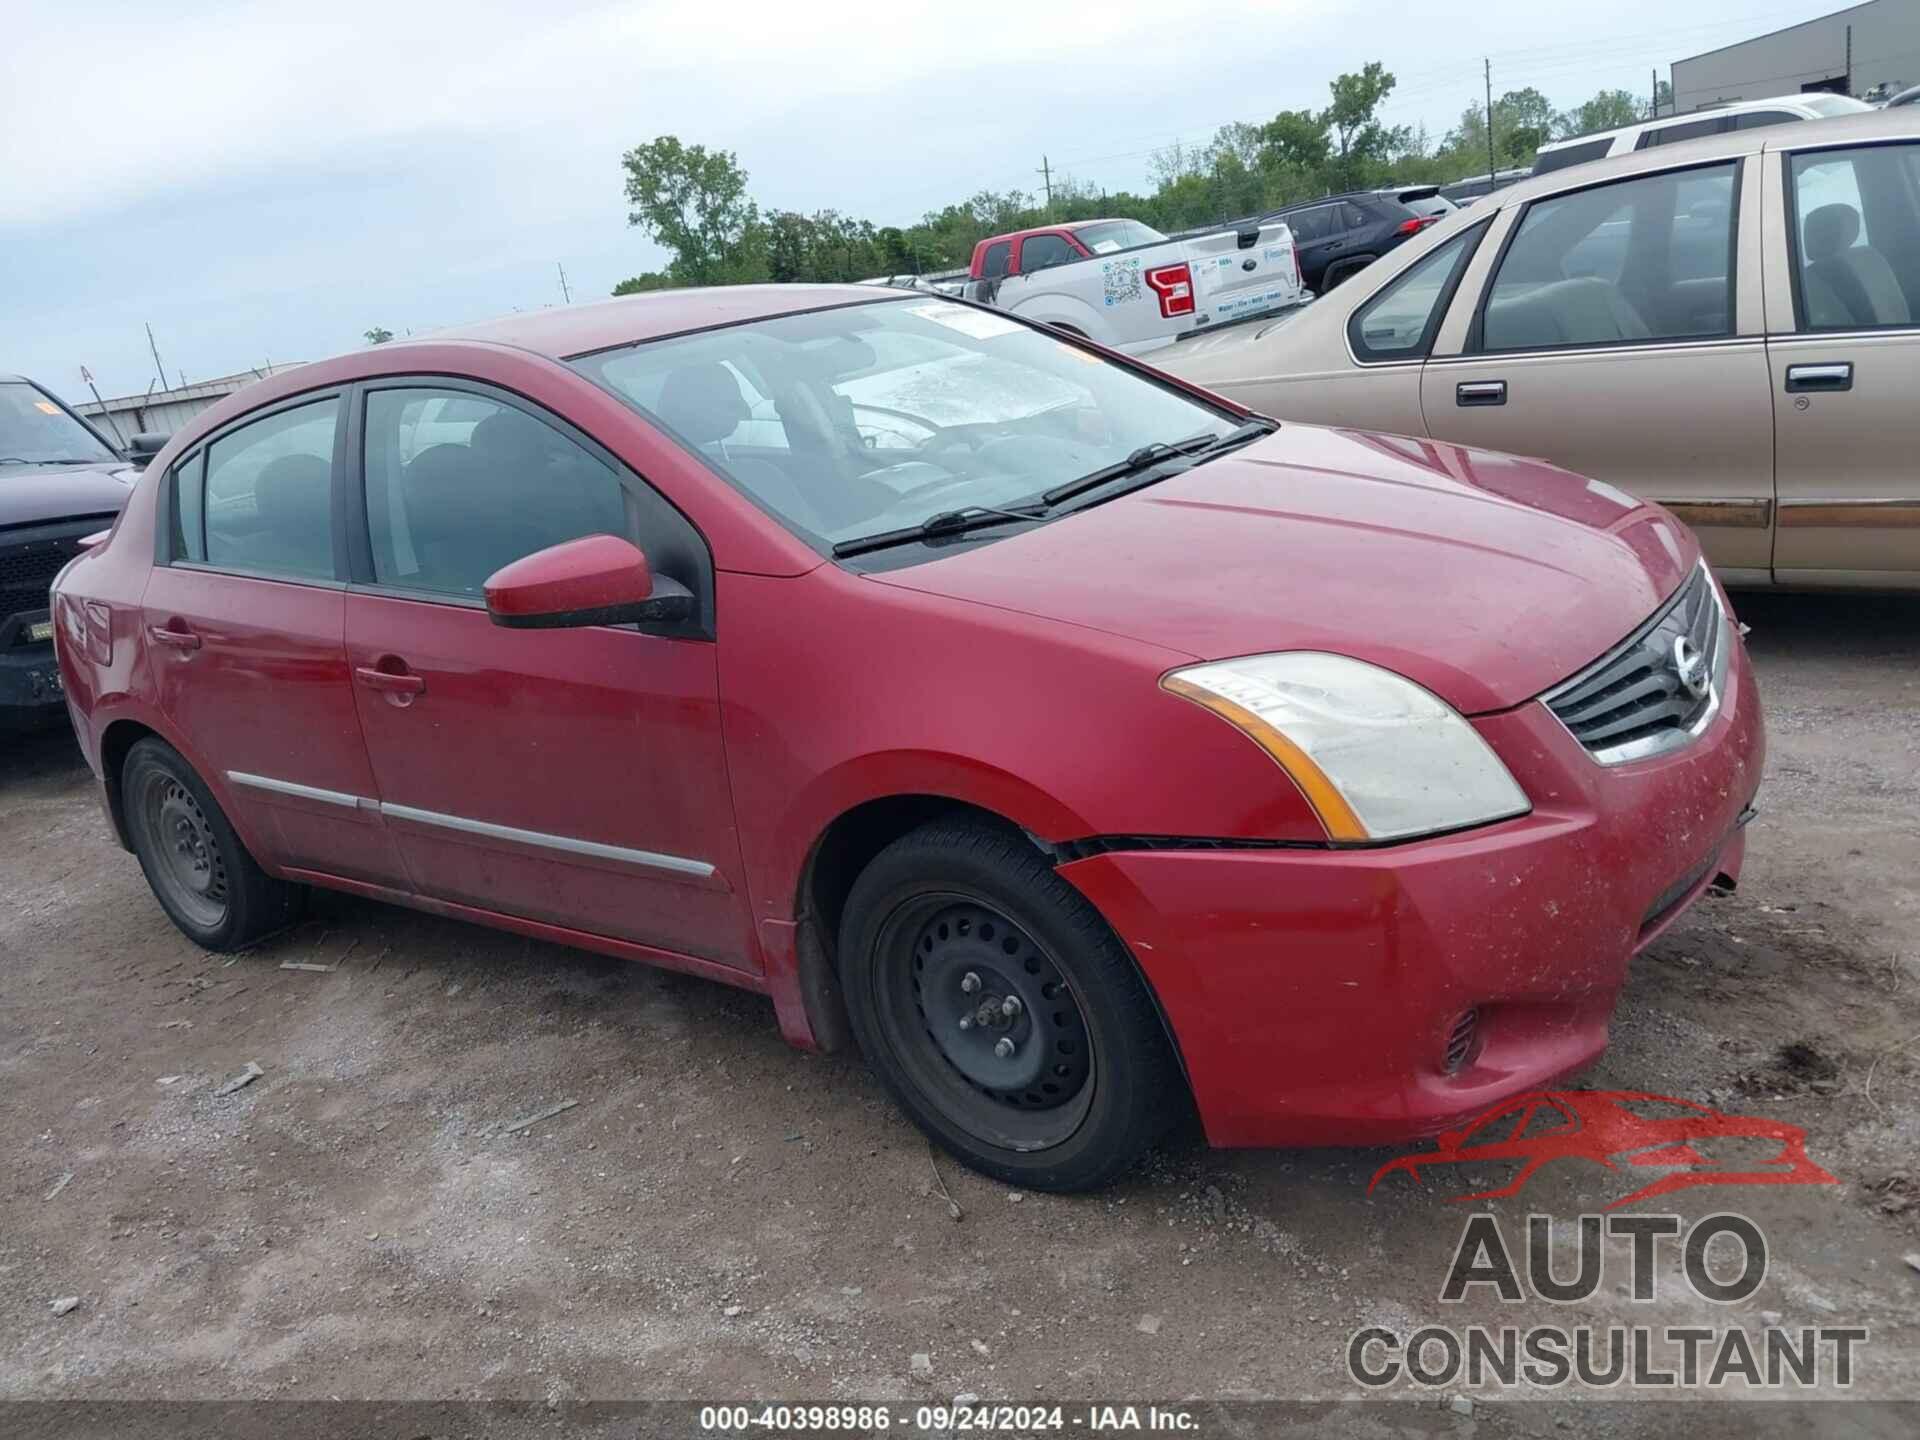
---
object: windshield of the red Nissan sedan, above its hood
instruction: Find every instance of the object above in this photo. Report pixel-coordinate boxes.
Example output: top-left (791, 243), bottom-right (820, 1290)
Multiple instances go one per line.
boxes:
top-left (572, 300), bottom-right (1238, 549)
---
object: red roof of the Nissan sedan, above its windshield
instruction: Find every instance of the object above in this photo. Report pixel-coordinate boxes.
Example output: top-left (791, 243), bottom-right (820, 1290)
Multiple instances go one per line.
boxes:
top-left (415, 284), bottom-right (906, 359)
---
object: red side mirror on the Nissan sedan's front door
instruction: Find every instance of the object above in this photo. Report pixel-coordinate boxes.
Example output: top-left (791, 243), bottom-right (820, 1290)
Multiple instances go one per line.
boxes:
top-left (484, 536), bottom-right (693, 630)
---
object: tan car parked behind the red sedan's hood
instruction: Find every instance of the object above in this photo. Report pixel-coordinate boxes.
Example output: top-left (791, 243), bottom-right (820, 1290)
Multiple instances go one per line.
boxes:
top-left (1146, 108), bottom-right (1920, 588)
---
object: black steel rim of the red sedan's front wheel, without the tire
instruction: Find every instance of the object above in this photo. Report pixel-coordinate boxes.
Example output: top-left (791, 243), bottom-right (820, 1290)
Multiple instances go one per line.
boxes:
top-left (876, 893), bottom-right (1094, 1150)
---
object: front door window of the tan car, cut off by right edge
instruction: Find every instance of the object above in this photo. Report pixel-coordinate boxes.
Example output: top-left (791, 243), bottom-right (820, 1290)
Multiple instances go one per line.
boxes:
top-left (1788, 144), bottom-right (1920, 330)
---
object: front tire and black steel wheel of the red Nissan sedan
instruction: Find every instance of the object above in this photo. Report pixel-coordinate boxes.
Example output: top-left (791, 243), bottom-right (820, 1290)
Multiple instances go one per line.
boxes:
top-left (839, 820), bottom-right (1188, 1190)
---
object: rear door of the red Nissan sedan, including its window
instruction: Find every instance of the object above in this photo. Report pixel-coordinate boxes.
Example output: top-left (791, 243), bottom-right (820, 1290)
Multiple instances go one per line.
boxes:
top-left (142, 396), bottom-right (403, 885)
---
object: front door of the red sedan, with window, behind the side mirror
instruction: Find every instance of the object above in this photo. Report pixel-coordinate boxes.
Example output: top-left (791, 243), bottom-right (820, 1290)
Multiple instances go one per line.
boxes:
top-left (346, 382), bottom-right (756, 968)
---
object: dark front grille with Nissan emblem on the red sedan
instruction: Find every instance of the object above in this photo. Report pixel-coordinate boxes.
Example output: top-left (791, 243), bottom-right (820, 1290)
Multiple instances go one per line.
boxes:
top-left (1542, 564), bottom-right (1728, 764)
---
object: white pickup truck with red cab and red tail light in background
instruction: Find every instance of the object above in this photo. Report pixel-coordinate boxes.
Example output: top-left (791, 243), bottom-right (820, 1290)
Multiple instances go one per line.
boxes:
top-left (966, 221), bottom-right (1313, 355)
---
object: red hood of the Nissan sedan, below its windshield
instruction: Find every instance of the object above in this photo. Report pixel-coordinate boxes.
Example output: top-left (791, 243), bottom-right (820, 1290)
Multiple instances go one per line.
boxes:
top-left (874, 424), bottom-right (1699, 714)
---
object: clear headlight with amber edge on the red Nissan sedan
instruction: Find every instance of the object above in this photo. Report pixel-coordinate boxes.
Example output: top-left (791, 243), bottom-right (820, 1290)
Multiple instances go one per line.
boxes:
top-left (1160, 651), bottom-right (1532, 843)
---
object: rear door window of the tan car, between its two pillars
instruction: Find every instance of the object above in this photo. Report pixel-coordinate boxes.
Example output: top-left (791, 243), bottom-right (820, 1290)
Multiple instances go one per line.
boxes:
top-left (1480, 163), bottom-right (1736, 351)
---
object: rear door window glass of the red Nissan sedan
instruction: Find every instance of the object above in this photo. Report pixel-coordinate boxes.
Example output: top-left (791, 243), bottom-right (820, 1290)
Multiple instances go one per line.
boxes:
top-left (189, 397), bottom-right (340, 580)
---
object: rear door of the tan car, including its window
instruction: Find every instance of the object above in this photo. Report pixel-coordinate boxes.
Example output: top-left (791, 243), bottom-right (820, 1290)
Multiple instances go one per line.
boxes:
top-left (1421, 161), bottom-right (1774, 582)
